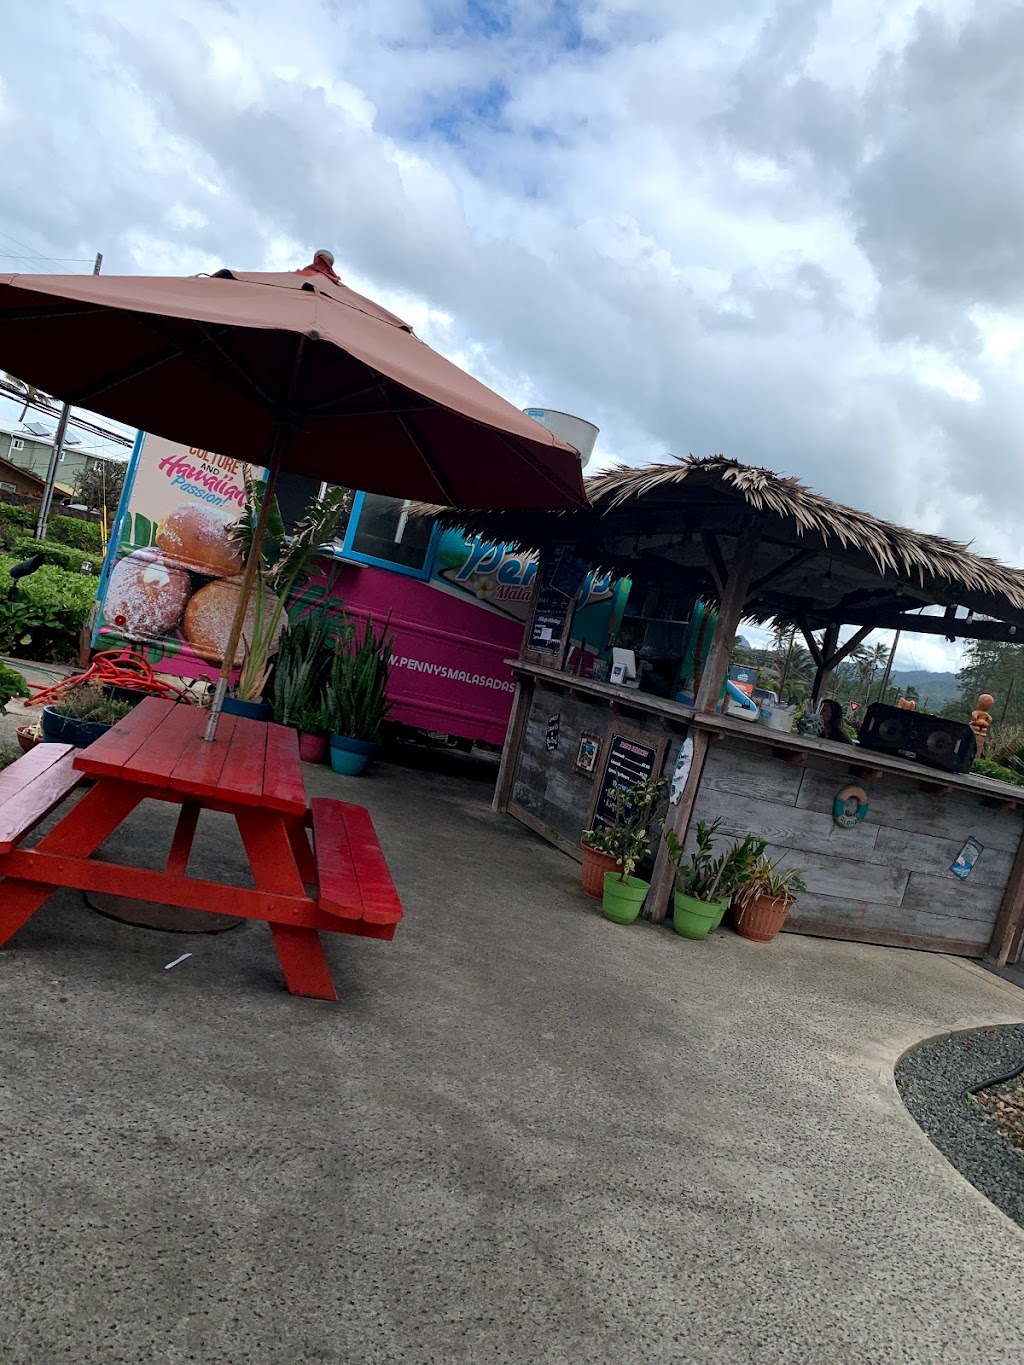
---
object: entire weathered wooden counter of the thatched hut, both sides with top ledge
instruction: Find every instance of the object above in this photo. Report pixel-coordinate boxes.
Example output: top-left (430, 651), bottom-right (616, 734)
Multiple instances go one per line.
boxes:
top-left (496, 662), bottom-right (1024, 957)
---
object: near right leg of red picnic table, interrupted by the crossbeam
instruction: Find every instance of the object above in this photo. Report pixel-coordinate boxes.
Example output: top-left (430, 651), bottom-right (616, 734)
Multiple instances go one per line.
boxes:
top-left (235, 809), bottom-right (337, 1001)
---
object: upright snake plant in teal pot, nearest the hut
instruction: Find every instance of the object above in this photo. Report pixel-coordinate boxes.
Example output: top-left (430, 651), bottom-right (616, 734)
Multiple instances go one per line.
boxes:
top-left (326, 617), bottom-right (395, 777)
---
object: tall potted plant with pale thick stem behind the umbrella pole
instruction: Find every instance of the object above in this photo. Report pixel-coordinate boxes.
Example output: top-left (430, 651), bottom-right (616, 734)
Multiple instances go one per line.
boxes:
top-left (224, 480), bottom-right (348, 721)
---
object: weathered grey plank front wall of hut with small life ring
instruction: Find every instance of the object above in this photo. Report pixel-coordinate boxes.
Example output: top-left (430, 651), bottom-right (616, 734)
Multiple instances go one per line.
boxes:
top-left (688, 740), bottom-right (1024, 957)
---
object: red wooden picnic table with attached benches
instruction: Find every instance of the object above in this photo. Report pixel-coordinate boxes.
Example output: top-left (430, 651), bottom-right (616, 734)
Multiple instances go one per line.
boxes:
top-left (0, 698), bottom-right (401, 1001)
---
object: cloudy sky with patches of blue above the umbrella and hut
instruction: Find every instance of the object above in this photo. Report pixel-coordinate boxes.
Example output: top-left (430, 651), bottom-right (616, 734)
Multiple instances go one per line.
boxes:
top-left (0, 0), bottom-right (1024, 666)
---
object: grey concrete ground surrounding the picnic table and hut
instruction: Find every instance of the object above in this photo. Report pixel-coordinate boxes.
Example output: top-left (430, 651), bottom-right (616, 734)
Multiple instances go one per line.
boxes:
top-left (0, 764), bottom-right (1024, 1365)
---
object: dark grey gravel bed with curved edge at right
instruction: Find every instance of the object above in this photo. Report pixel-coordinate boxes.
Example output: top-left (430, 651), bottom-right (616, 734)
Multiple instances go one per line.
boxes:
top-left (896, 1024), bottom-right (1024, 1227)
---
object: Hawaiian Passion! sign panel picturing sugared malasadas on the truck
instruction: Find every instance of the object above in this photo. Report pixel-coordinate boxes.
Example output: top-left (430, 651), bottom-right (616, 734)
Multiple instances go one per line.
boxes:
top-left (93, 433), bottom-right (264, 678)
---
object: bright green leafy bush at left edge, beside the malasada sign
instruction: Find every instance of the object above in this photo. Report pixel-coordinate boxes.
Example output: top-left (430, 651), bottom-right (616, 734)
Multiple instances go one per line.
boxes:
top-left (0, 554), bottom-right (100, 663)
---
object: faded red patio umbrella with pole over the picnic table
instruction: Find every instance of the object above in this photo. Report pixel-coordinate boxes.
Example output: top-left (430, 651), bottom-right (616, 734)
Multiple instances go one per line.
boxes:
top-left (0, 251), bottom-right (587, 737)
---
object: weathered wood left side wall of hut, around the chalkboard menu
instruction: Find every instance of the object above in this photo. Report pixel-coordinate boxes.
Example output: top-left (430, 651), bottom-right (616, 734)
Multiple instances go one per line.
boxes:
top-left (508, 684), bottom-right (684, 859)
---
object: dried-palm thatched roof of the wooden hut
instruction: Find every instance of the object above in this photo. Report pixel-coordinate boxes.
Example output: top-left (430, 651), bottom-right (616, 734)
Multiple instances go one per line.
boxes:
top-left (418, 456), bottom-right (1024, 635)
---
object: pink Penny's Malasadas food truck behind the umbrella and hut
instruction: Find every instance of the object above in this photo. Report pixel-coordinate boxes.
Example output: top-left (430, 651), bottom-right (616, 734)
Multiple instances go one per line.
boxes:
top-left (93, 410), bottom-right (628, 745)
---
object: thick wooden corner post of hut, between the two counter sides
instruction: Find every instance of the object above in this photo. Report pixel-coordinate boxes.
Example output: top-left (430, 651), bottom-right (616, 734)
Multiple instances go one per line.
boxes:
top-left (643, 528), bottom-right (760, 924)
